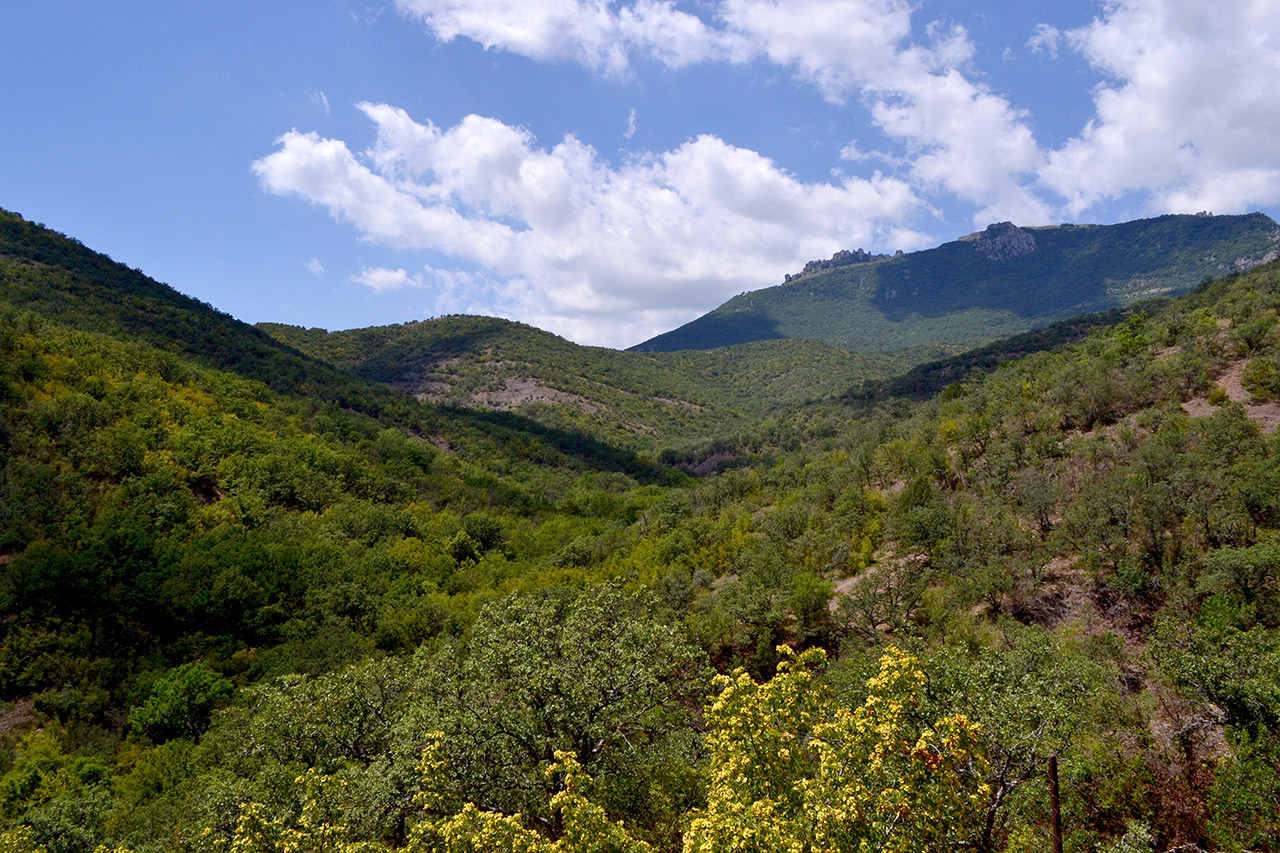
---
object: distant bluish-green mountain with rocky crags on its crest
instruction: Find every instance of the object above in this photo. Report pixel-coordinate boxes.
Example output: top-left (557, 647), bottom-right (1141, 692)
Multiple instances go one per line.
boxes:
top-left (632, 213), bottom-right (1280, 352)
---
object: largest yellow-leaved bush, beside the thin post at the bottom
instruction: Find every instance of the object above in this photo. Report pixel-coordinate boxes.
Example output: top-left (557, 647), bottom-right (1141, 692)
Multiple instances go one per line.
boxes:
top-left (685, 647), bottom-right (987, 853)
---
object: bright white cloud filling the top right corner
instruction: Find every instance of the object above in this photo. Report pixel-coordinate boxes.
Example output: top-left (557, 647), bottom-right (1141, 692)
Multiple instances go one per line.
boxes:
top-left (1042, 0), bottom-right (1280, 214)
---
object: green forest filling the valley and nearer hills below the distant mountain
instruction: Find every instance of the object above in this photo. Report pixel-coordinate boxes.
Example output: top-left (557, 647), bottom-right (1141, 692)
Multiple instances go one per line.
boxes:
top-left (0, 207), bottom-right (1280, 853)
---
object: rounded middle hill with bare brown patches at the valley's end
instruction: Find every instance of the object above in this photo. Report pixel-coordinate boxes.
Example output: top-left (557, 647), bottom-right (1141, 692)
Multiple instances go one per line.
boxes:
top-left (259, 316), bottom-right (924, 439)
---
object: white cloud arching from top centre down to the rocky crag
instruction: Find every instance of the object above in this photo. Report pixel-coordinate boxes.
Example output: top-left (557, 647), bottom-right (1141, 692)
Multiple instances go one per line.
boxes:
top-left (398, 0), bottom-right (1052, 224)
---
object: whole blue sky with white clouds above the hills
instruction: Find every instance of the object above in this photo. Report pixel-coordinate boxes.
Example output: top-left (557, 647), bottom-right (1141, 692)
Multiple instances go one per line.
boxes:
top-left (0, 0), bottom-right (1280, 347)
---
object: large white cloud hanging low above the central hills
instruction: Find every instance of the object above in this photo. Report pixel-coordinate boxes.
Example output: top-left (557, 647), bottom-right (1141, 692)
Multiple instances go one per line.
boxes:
top-left (253, 104), bottom-right (927, 346)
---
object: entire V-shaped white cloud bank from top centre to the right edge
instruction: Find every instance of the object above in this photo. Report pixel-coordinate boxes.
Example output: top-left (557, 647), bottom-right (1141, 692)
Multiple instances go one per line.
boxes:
top-left (384, 0), bottom-right (1280, 224)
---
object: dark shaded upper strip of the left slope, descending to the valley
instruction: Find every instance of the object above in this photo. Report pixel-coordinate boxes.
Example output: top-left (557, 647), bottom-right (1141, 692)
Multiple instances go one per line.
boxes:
top-left (0, 209), bottom-right (686, 480)
